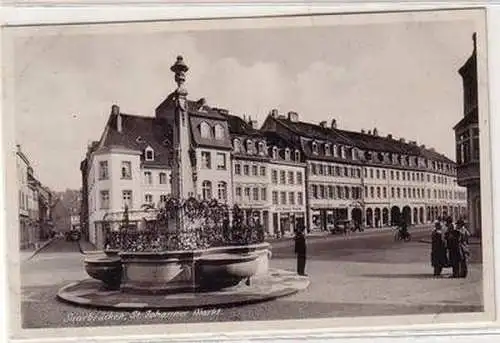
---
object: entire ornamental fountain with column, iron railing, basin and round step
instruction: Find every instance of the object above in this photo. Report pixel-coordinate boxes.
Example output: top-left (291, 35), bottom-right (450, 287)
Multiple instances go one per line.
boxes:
top-left (58, 56), bottom-right (309, 310)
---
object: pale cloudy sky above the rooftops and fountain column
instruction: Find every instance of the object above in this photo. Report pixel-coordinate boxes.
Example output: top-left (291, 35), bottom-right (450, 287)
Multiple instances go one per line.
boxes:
top-left (14, 14), bottom-right (474, 191)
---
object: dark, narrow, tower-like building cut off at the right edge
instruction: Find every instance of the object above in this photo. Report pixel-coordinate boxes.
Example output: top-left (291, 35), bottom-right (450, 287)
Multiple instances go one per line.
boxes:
top-left (453, 34), bottom-right (481, 236)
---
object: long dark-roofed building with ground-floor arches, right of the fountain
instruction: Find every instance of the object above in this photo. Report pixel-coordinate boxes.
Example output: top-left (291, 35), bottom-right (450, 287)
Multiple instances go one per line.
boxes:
top-left (262, 112), bottom-right (465, 229)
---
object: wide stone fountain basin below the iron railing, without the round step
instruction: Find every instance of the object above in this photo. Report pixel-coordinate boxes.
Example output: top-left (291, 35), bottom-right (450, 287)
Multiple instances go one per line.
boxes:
top-left (85, 243), bottom-right (271, 294)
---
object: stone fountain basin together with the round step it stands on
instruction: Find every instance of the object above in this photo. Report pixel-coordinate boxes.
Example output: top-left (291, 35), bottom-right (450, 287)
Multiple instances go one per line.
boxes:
top-left (58, 243), bottom-right (309, 310)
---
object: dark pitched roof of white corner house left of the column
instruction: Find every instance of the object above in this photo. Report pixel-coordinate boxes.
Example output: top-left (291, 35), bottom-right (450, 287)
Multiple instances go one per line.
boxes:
top-left (99, 113), bottom-right (173, 165)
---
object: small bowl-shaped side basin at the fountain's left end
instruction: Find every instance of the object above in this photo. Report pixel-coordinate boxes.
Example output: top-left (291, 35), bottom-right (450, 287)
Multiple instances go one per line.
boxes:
top-left (84, 256), bottom-right (123, 290)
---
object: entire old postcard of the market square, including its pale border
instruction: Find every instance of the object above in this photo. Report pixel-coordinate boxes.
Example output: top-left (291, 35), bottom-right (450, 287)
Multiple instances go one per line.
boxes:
top-left (3, 9), bottom-right (495, 343)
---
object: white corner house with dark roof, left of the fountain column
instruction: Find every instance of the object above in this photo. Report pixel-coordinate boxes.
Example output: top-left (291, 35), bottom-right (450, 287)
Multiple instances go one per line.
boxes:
top-left (80, 105), bottom-right (175, 247)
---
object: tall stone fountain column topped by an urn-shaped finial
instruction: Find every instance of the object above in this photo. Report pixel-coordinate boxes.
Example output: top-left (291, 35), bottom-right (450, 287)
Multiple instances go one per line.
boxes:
top-left (170, 56), bottom-right (194, 230)
